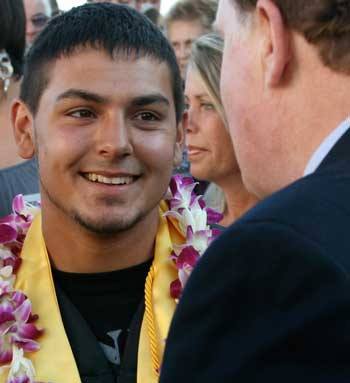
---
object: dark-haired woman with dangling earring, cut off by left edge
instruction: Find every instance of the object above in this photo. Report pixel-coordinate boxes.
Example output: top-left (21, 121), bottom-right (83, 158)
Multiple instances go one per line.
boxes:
top-left (0, 0), bottom-right (39, 217)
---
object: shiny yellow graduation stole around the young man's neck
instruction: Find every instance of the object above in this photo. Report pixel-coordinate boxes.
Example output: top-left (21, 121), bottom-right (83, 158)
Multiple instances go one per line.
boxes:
top-left (0, 202), bottom-right (184, 383)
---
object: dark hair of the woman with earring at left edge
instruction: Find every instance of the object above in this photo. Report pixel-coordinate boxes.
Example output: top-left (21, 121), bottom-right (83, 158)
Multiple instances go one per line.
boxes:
top-left (0, 0), bottom-right (26, 76)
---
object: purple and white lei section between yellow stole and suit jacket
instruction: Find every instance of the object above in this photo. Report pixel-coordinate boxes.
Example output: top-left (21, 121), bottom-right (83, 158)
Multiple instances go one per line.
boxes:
top-left (165, 175), bottom-right (222, 302)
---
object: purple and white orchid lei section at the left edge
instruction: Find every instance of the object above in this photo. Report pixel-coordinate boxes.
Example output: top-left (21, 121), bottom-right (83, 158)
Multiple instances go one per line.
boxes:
top-left (0, 195), bottom-right (43, 383)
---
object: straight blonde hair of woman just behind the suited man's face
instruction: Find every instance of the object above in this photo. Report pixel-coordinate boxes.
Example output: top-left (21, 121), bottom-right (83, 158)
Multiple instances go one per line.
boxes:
top-left (189, 33), bottom-right (227, 127)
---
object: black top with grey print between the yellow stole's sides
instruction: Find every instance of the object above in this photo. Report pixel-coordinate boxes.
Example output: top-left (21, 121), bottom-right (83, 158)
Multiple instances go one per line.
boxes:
top-left (53, 261), bottom-right (152, 382)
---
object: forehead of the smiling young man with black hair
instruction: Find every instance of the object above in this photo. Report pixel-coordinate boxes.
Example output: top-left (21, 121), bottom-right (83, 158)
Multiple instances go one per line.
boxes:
top-left (39, 50), bottom-right (172, 105)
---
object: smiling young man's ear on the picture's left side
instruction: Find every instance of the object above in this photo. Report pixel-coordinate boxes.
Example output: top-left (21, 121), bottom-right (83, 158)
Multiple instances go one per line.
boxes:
top-left (11, 100), bottom-right (35, 159)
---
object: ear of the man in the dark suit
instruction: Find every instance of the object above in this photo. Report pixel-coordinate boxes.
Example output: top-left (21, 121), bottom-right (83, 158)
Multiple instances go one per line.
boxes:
top-left (256, 0), bottom-right (291, 87)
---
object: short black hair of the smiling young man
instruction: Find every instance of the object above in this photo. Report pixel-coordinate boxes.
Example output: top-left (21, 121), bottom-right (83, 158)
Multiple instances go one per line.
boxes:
top-left (20, 3), bottom-right (183, 122)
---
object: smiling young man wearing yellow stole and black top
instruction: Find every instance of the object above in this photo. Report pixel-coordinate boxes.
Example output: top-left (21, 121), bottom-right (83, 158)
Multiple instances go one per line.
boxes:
top-left (0, 4), bottom-right (183, 383)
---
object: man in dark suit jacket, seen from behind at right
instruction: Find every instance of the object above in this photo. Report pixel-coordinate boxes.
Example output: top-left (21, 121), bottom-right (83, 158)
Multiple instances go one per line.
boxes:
top-left (161, 0), bottom-right (350, 383)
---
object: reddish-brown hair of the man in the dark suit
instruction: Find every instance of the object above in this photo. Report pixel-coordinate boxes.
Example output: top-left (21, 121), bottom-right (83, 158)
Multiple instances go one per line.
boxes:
top-left (231, 0), bottom-right (350, 75)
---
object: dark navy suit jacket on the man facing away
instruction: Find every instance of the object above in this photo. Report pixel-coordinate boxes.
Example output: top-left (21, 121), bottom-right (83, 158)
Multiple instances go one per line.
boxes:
top-left (160, 131), bottom-right (350, 383)
